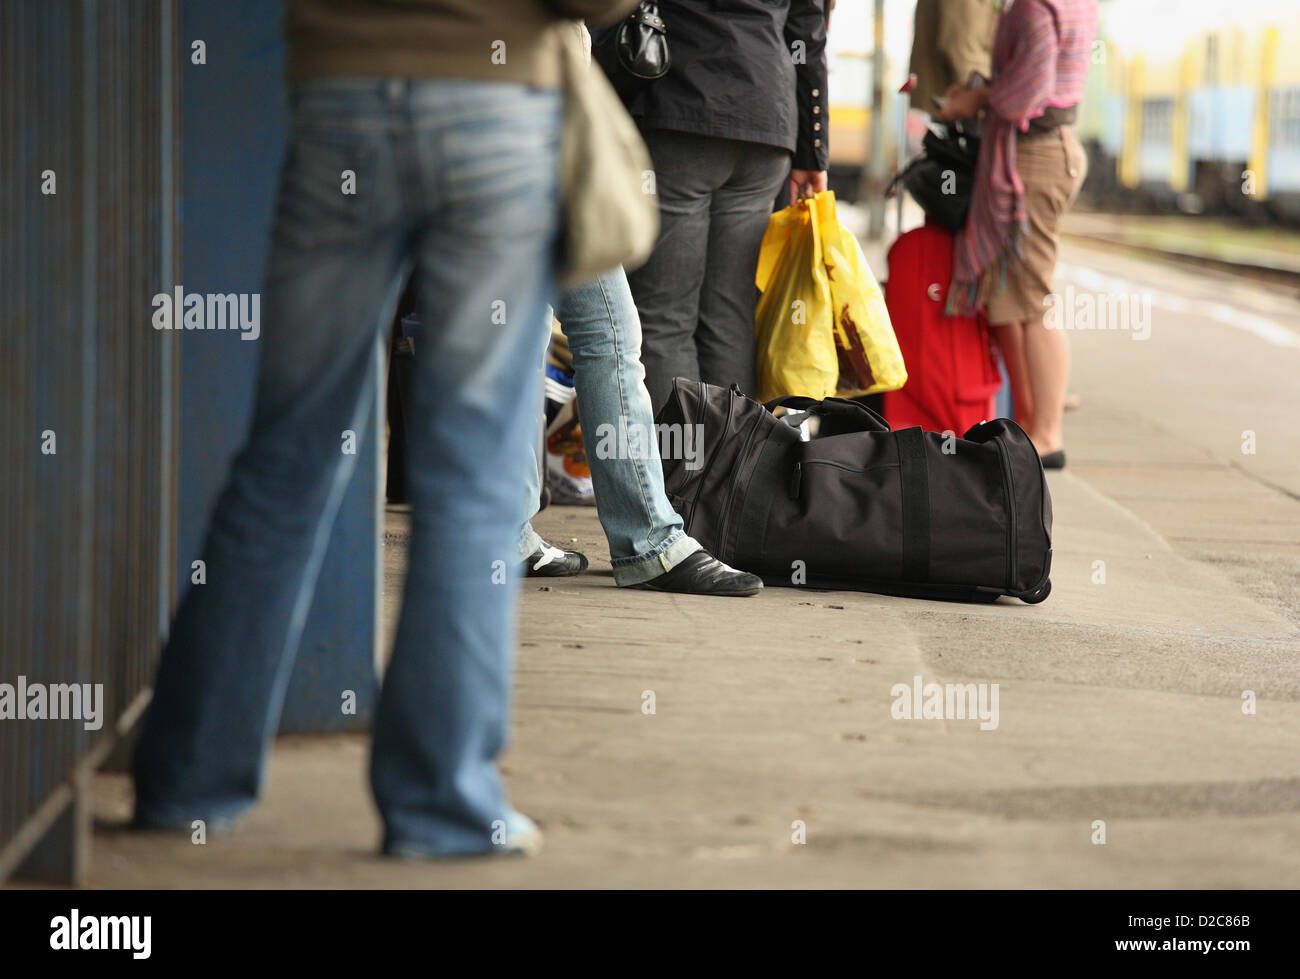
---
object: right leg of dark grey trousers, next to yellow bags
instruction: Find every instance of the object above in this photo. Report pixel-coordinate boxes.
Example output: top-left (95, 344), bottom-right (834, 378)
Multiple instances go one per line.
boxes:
top-left (696, 142), bottom-right (790, 397)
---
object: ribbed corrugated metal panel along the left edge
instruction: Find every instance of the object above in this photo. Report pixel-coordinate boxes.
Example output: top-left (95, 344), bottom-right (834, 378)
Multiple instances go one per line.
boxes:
top-left (0, 0), bottom-right (177, 874)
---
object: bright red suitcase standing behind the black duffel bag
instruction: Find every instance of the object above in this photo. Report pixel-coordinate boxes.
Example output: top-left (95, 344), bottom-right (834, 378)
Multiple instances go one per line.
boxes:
top-left (881, 225), bottom-right (1002, 436)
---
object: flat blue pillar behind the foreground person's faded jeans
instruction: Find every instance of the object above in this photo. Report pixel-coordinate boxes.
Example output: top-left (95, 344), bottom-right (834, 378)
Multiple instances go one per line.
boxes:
top-left (176, 0), bottom-right (382, 732)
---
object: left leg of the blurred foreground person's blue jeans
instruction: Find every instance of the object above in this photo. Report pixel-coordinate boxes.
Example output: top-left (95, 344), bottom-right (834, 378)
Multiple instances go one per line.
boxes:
top-left (134, 88), bottom-right (408, 828)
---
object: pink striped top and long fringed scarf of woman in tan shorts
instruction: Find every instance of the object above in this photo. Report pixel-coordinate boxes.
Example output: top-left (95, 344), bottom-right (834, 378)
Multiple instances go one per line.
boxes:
top-left (948, 0), bottom-right (1097, 315)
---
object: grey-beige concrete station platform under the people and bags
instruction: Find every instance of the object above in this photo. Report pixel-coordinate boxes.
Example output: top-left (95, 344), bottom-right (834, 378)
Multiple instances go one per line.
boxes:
top-left (78, 236), bottom-right (1300, 888)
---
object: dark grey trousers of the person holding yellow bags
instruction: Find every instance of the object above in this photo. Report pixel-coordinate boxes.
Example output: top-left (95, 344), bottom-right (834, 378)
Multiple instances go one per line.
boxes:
top-left (628, 129), bottom-right (790, 411)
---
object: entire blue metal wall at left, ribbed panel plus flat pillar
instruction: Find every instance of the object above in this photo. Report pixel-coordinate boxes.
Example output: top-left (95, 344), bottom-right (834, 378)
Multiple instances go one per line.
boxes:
top-left (0, 0), bottom-right (382, 881)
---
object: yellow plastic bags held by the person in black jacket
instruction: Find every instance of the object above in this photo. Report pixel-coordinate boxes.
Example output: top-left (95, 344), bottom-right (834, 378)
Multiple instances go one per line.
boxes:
top-left (754, 191), bottom-right (907, 400)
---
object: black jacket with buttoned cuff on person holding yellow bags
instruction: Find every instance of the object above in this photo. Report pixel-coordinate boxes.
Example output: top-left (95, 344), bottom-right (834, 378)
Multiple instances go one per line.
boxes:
top-left (629, 0), bottom-right (828, 170)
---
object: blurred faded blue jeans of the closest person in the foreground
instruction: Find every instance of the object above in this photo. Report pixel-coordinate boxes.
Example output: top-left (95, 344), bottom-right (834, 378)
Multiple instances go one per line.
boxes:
top-left (134, 79), bottom-right (562, 854)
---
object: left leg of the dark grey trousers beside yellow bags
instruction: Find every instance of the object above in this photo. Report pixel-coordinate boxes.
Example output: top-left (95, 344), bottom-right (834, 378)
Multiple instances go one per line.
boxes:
top-left (628, 129), bottom-right (731, 410)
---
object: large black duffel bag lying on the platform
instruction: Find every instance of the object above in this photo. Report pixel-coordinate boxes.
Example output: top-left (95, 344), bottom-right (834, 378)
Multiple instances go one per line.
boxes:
top-left (655, 377), bottom-right (1052, 603)
